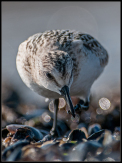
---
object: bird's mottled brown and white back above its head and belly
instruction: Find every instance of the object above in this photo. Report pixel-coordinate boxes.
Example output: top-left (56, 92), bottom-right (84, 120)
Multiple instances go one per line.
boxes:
top-left (26, 30), bottom-right (108, 67)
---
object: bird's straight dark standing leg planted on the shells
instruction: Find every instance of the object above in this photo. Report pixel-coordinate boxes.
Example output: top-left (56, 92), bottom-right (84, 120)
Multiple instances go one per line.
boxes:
top-left (42, 99), bottom-right (59, 142)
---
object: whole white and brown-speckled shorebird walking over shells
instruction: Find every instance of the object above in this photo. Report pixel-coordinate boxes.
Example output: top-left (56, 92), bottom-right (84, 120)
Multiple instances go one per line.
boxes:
top-left (16, 30), bottom-right (108, 140)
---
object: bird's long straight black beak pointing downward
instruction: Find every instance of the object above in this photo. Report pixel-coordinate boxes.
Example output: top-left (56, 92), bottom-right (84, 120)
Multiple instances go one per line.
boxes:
top-left (61, 85), bottom-right (75, 118)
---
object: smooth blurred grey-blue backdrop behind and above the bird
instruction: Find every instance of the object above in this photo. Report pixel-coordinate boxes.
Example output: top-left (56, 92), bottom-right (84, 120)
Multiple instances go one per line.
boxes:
top-left (2, 2), bottom-right (120, 106)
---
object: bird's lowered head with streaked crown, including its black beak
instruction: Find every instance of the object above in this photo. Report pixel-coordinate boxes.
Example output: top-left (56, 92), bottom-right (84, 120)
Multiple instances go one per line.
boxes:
top-left (38, 51), bottom-right (74, 116)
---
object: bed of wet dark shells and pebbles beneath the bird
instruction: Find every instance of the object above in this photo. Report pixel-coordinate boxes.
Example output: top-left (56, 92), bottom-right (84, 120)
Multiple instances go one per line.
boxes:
top-left (2, 88), bottom-right (121, 162)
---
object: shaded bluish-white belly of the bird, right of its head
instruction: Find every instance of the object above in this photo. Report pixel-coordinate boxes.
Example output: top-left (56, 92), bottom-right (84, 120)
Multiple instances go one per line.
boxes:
top-left (70, 63), bottom-right (103, 97)
